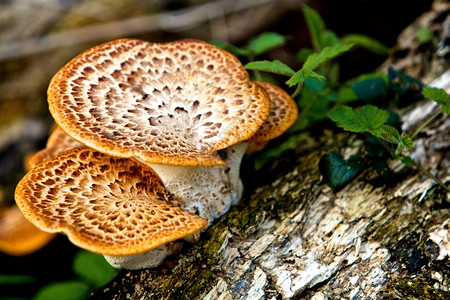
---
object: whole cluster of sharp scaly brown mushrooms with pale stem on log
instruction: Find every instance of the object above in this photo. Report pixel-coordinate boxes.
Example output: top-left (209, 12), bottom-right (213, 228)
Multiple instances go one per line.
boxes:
top-left (16, 39), bottom-right (296, 269)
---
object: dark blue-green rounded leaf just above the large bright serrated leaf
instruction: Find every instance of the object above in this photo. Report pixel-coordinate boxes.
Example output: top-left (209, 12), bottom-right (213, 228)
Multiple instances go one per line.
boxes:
top-left (350, 78), bottom-right (387, 103)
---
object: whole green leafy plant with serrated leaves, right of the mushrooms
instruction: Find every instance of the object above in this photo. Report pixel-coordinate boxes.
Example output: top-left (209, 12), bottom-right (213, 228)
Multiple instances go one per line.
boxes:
top-left (218, 6), bottom-right (450, 190)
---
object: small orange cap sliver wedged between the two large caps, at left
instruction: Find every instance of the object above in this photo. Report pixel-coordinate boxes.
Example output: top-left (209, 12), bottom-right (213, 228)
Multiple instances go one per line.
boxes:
top-left (28, 127), bottom-right (84, 169)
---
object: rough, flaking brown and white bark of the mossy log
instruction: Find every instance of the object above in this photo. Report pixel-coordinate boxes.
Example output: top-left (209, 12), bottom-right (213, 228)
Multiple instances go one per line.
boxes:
top-left (91, 1), bottom-right (450, 299)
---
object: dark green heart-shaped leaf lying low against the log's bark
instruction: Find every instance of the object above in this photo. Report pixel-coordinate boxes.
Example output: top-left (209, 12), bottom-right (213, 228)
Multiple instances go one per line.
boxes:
top-left (319, 152), bottom-right (365, 188)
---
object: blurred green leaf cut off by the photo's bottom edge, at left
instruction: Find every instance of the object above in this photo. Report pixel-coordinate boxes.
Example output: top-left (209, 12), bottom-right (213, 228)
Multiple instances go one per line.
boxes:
top-left (33, 280), bottom-right (90, 300)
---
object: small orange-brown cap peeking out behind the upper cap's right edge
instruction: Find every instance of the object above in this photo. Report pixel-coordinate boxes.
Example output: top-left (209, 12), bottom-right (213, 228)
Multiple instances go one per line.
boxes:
top-left (250, 81), bottom-right (298, 144)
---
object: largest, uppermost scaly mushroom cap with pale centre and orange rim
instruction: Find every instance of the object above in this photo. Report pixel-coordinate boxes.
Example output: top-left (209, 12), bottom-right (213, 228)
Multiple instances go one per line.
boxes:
top-left (48, 39), bottom-right (270, 166)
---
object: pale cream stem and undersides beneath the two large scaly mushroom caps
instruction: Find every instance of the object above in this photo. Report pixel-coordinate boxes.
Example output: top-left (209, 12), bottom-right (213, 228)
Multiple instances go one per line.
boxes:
top-left (105, 142), bottom-right (249, 269)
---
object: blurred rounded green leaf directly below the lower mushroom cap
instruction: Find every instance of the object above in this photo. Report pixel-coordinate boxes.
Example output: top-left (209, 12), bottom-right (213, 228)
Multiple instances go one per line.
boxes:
top-left (73, 250), bottom-right (118, 288)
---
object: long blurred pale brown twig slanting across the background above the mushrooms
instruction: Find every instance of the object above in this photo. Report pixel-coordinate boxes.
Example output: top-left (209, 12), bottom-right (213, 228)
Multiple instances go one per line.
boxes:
top-left (0, 0), bottom-right (277, 61)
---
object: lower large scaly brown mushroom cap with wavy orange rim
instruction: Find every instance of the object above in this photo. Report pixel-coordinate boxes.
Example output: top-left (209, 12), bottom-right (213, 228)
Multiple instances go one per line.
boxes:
top-left (15, 147), bottom-right (207, 255)
